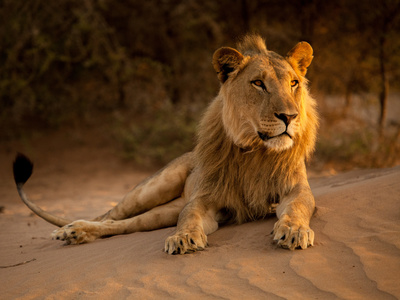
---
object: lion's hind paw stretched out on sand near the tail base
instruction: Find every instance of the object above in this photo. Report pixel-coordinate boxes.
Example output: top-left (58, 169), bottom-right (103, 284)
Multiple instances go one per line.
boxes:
top-left (51, 220), bottom-right (99, 245)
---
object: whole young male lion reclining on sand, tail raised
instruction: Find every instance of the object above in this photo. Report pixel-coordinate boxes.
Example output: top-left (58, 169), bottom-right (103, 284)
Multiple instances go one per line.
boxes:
top-left (14, 35), bottom-right (318, 254)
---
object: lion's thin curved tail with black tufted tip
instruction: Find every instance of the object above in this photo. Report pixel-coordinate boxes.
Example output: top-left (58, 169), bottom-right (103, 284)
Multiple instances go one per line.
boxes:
top-left (13, 153), bottom-right (71, 227)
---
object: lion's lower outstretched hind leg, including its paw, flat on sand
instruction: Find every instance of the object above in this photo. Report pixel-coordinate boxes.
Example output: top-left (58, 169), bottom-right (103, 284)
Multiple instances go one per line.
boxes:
top-left (52, 198), bottom-right (186, 244)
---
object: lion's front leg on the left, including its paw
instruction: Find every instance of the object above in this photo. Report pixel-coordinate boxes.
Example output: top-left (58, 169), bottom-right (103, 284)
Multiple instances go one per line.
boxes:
top-left (164, 200), bottom-right (218, 254)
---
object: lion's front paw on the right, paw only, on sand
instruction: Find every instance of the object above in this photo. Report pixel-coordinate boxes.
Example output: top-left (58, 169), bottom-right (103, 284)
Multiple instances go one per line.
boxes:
top-left (273, 218), bottom-right (314, 250)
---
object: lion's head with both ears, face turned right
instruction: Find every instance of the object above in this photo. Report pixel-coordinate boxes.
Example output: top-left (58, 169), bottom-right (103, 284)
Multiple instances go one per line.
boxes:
top-left (213, 36), bottom-right (318, 156)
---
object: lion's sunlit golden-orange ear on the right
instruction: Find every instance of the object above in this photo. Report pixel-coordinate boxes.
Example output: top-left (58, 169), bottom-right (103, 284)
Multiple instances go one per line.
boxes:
top-left (286, 42), bottom-right (314, 76)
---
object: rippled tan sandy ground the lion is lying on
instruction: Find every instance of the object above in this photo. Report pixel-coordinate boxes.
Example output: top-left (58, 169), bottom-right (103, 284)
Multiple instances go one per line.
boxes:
top-left (0, 134), bottom-right (400, 299)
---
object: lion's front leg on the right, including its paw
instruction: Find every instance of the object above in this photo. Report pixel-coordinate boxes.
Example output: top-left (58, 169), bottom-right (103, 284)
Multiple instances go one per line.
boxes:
top-left (273, 183), bottom-right (315, 250)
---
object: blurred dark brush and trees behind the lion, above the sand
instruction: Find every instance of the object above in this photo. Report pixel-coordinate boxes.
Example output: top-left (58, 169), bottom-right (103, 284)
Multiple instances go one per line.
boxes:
top-left (0, 0), bottom-right (400, 173)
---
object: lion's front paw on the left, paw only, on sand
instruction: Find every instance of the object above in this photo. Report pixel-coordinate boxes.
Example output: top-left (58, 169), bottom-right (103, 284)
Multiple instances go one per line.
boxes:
top-left (164, 231), bottom-right (208, 254)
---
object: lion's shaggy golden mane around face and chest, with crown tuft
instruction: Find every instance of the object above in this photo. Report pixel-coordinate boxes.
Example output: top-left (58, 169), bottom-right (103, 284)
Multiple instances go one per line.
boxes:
top-left (194, 35), bottom-right (318, 223)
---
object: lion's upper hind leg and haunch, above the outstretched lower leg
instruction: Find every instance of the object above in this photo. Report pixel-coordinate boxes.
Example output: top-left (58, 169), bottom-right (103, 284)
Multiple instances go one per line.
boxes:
top-left (93, 153), bottom-right (193, 221)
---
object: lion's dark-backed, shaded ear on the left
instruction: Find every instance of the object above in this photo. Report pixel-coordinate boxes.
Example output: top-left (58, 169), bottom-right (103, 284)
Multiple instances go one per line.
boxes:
top-left (213, 47), bottom-right (244, 83)
